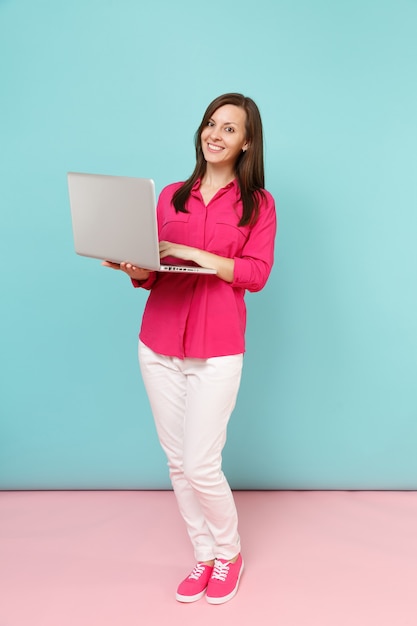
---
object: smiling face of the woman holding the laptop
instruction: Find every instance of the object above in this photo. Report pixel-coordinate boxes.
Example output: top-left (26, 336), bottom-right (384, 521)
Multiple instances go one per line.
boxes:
top-left (200, 104), bottom-right (247, 167)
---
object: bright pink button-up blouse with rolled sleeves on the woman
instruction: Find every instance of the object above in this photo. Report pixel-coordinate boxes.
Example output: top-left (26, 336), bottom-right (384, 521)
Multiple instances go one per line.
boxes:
top-left (132, 180), bottom-right (277, 359)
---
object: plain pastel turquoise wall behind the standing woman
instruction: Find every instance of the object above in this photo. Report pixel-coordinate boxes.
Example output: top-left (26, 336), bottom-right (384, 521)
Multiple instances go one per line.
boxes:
top-left (0, 0), bottom-right (417, 489)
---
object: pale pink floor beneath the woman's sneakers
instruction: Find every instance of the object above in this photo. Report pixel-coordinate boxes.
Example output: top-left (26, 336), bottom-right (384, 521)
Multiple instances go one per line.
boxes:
top-left (0, 491), bottom-right (417, 626)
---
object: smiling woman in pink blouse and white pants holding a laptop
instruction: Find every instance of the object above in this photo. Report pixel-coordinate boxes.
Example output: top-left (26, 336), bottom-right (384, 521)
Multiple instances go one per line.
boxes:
top-left (104, 93), bottom-right (276, 604)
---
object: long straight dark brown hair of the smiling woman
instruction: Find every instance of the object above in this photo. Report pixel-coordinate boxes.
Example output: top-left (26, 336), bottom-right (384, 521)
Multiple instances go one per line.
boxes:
top-left (172, 93), bottom-right (265, 226)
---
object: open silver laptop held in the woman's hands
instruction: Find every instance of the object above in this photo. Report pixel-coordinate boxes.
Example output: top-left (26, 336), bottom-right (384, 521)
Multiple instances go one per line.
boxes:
top-left (68, 172), bottom-right (216, 274)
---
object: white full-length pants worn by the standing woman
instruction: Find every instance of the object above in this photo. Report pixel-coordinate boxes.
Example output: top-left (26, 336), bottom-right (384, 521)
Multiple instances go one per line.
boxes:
top-left (139, 342), bottom-right (243, 561)
